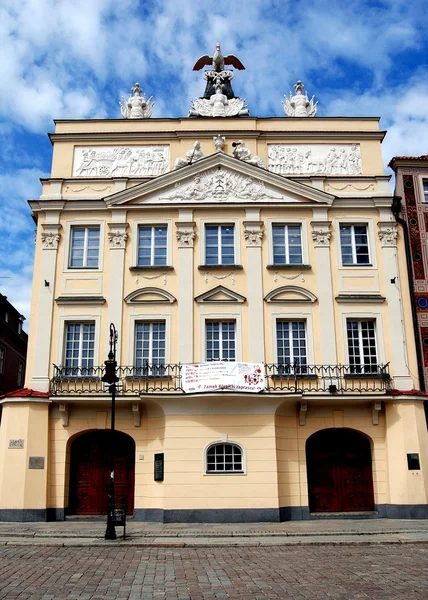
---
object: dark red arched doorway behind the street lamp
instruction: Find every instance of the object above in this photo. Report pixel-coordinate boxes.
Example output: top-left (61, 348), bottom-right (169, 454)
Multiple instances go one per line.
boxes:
top-left (69, 430), bottom-right (135, 515)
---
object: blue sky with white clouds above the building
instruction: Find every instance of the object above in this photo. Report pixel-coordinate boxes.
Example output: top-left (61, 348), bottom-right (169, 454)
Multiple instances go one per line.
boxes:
top-left (0, 0), bottom-right (428, 326)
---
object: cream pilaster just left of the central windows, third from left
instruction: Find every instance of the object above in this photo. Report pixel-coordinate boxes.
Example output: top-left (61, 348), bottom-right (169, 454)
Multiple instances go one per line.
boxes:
top-left (175, 210), bottom-right (196, 363)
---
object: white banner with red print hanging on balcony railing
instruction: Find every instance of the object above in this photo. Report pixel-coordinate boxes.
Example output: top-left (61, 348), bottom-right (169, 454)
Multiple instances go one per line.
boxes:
top-left (181, 361), bottom-right (265, 394)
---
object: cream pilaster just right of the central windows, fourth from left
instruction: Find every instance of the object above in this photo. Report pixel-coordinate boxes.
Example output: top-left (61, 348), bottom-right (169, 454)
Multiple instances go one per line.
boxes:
top-left (243, 209), bottom-right (265, 362)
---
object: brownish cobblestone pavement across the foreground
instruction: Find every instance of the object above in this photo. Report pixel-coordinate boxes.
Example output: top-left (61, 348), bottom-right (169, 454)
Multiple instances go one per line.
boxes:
top-left (0, 544), bottom-right (428, 600)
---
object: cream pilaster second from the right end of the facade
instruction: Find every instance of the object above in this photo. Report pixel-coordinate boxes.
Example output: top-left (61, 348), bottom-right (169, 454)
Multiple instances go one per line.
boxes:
top-left (311, 209), bottom-right (337, 365)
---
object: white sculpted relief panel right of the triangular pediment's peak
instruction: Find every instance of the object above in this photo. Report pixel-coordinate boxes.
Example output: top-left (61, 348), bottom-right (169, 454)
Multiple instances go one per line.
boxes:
top-left (268, 144), bottom-right (362, 175)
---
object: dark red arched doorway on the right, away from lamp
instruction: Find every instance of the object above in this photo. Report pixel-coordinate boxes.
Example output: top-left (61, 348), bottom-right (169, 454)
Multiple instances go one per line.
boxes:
top-left (306, 429), bottom-right (374, 512)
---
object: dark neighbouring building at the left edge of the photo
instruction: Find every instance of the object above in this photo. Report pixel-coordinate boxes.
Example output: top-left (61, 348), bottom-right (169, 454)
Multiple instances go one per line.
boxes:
top-left (0, 294), bottom-right (28, 394)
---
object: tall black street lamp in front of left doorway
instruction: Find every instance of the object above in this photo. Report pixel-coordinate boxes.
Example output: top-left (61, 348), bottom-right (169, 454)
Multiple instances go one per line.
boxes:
top-left (101, 323), bottom-right (119, 540)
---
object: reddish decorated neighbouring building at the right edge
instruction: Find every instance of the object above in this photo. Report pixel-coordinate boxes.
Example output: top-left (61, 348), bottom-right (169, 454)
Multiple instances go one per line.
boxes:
top-left (389, 154), bottom-right (428, 390)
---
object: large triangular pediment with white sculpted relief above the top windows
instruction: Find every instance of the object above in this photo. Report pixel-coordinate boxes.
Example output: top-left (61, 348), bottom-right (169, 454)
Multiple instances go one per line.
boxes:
top-left (104, 152), bottom-right (334, 208)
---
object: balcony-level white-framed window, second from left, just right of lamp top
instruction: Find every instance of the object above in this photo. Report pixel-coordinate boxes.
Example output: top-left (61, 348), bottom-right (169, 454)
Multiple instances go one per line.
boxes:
top-left (135, 321), bottom-right (166, 376)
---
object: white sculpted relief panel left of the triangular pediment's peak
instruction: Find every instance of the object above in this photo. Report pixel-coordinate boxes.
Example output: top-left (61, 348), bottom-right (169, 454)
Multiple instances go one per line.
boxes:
top-left (73, 146), bottom-right (169, 177)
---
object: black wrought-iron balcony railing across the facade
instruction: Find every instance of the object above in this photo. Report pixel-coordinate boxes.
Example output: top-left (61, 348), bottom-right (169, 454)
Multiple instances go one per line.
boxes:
top-left (50, 363), bottom-right (391, 396)
